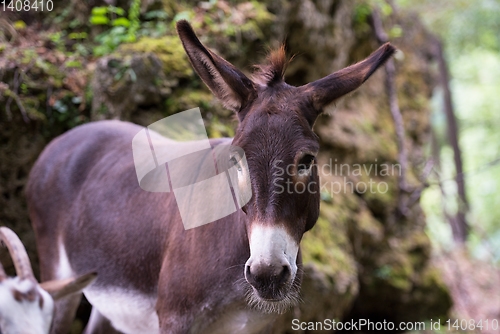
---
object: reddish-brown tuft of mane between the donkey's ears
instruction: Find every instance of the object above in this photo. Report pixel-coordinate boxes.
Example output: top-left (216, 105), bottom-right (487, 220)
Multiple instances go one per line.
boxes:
top-left (252, 44), bottom-right (293, 86)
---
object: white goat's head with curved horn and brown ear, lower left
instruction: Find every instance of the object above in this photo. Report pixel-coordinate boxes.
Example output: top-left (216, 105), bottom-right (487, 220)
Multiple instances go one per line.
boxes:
top-left (0, 227), bottom-right (96, 334)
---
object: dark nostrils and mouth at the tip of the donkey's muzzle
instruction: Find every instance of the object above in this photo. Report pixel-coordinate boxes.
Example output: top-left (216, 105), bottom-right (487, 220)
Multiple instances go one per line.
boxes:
top-left (245, 263), bottom-right (292, 301)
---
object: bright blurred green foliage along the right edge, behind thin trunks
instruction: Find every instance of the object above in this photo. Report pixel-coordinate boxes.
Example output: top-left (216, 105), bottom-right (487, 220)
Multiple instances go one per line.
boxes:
top-left (398, 0), bottom-right (500, 263)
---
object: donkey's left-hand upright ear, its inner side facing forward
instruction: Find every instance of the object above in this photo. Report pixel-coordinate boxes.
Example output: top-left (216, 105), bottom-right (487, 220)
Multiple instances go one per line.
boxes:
top-left (177, 20), bottom-right (256, 111)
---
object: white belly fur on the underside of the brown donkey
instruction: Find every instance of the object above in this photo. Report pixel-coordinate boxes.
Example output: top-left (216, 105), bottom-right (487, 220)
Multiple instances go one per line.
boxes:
top-left (83, 286), bottom-right (160, 334)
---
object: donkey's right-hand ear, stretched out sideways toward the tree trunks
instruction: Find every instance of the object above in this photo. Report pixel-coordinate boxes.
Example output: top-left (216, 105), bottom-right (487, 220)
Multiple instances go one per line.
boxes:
top-left (302, 43), bottom-right (396, 113)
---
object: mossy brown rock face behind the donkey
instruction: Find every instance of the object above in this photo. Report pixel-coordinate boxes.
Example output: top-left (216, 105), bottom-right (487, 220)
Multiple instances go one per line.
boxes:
top-left (0, 0), bottom-right (451, 333)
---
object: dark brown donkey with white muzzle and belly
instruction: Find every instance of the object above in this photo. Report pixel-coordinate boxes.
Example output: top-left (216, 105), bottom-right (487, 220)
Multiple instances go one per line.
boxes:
top-left (27, 20), bottom-right (395, 334)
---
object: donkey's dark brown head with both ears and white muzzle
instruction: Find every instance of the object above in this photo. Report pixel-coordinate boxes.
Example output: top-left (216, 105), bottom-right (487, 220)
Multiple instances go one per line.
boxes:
top-left (177, 20), bottom-right (395, 312)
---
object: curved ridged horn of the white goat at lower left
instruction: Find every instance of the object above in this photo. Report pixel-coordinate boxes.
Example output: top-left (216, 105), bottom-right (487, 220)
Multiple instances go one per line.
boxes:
top-left (0, 227), bottom-right (35, 280)
